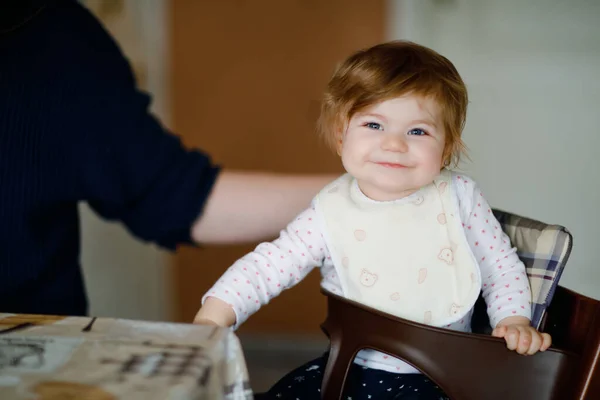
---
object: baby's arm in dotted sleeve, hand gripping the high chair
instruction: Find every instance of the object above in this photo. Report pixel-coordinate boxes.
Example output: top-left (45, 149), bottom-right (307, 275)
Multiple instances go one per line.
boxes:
top-left (462, 177), bottom-right (551, 354)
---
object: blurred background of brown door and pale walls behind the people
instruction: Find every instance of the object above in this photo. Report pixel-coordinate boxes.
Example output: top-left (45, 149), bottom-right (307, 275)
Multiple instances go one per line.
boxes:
top-left (81, 0), bottom-right (600, 391)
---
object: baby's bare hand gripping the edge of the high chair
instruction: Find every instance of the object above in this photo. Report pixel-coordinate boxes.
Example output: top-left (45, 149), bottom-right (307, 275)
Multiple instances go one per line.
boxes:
top-left (492, 317), bottom-right (552, 355)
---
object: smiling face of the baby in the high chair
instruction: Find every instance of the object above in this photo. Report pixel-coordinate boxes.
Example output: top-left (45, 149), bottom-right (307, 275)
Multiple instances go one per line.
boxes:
top-left (341, 95), bottom-right (445, 201)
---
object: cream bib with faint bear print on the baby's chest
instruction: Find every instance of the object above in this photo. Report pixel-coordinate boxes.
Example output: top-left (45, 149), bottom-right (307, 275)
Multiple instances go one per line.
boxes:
top-left (315, 169), bottom-right (481, 326)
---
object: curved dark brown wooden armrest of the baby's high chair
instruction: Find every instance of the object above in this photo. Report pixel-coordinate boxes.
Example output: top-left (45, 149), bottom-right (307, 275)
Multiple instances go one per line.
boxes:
top-left (322, 290), bottom-right (580, 400)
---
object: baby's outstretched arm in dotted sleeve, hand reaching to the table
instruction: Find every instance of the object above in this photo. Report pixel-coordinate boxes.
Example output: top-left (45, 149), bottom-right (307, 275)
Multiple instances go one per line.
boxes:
top-left (194, 208), bottom-right (328, 328)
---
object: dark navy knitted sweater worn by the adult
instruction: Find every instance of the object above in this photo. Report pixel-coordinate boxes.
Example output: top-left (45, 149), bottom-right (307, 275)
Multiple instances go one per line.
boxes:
top-left (0, 0), bottom-right (218, 315)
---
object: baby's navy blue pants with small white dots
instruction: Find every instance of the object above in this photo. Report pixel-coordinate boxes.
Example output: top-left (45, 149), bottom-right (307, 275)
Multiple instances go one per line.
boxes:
top-left (254, 354), bottom-right (449, 400)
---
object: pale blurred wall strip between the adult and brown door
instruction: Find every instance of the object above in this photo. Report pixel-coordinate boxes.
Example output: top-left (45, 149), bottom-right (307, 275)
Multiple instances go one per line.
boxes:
top-left (80, 0), bottom-right (173, 320)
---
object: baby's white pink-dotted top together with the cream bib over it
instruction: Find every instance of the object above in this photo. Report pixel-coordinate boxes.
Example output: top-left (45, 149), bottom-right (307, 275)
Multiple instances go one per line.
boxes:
top-left (203, 170), bottom-right (531, 373)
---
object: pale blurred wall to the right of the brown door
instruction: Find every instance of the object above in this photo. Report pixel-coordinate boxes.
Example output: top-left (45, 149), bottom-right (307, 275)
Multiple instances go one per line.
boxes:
top-left (388, 0), bottom-right (600, 299)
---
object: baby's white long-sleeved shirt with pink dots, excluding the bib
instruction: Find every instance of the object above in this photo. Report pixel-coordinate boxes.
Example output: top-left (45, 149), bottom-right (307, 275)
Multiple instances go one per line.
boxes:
top-left (203, 173), bottom-right (531, 373)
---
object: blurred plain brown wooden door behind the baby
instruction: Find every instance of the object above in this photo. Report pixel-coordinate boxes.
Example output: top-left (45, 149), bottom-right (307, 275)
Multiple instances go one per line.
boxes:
top-left (171, 0), bottom-right (385, 334)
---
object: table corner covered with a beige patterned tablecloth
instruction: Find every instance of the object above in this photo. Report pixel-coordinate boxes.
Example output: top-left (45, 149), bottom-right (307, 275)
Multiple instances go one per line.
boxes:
top-left (0, 313), bottom-right (252, 400)
